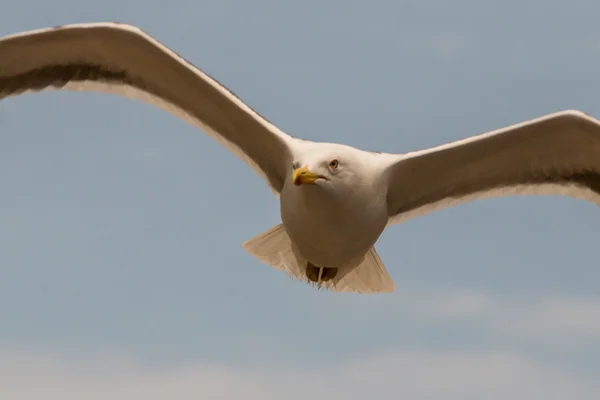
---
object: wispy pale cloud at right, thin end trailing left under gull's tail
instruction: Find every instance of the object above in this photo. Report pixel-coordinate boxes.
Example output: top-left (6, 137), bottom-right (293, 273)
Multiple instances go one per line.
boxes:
top-left (322, 287), bottom-right (600, 352)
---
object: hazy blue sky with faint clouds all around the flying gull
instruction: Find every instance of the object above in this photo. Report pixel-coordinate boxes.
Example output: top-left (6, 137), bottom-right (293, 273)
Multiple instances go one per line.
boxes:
top-left (0, 0), bottom-right (600, 400)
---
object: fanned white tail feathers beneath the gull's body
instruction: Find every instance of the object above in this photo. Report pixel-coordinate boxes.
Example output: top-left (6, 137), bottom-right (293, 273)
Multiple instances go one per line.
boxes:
top-left (242, 224), bottom-right (396, 293)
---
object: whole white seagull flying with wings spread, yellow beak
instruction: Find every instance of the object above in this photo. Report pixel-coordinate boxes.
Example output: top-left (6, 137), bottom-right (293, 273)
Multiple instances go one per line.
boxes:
top-left (0, 22), bottom-right (600, 293)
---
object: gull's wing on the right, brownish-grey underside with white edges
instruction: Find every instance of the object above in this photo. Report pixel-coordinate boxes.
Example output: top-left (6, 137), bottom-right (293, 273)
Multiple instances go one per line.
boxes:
top-left (386, 111), bottom-right (600, 224)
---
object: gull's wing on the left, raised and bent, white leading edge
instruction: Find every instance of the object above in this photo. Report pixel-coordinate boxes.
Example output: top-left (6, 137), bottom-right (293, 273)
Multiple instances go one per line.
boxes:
top-left (0, 23), bottom-right (293, 194)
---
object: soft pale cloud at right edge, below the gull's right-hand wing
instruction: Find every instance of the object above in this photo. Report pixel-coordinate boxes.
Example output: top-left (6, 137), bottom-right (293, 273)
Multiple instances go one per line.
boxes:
top-left (406, 290), bottom-right (600, 348)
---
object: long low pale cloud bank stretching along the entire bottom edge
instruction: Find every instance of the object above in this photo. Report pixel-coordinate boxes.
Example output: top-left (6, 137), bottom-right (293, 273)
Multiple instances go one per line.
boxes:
top-left (0, 349), bottom-right (600, 400)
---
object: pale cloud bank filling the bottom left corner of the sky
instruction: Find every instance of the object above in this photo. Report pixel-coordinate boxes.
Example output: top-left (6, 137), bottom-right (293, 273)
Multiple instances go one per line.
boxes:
top-left (0, 352), bottom-right (268, 400)
